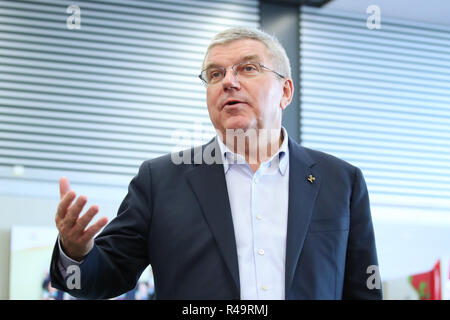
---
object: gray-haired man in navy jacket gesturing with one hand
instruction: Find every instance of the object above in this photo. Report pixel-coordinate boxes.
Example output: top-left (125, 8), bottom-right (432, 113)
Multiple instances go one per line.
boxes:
top-left (51, 28), bottom-right (381, 299)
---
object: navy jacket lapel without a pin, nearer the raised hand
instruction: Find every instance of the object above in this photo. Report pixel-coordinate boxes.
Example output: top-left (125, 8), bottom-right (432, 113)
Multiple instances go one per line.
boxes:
top-left (188, 140), bottom-right (240, 292)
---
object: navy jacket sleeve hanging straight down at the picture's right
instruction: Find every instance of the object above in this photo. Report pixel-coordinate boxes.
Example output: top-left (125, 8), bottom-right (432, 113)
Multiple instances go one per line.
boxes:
top-left (343, 168), bottom-right (382, 299)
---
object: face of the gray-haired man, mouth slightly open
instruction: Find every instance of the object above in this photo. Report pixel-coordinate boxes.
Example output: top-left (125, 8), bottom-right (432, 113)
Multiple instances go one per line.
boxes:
top-left (205, 39), bottom-right (292, 135)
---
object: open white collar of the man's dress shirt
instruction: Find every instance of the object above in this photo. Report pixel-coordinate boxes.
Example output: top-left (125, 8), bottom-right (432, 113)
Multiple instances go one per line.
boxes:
top-left (216, 127), bottom-right (289, 176)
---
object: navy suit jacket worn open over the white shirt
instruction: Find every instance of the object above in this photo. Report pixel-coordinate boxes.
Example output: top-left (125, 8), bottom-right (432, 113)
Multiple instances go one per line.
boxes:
top-left (51, 138), bottom-right (381, 300)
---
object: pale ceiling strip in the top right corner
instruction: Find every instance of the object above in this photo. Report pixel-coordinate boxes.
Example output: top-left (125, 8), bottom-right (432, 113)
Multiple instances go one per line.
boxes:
top-left (324, 0), bottom-right (450, 26)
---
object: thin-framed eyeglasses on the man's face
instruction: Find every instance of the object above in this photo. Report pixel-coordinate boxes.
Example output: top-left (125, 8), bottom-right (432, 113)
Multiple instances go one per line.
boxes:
top-left (198, 61), bottom-right (284, 86)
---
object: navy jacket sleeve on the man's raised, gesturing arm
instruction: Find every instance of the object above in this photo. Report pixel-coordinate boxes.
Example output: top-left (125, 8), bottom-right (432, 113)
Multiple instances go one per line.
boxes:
top-left (50, 162), bottom-right (151, 299)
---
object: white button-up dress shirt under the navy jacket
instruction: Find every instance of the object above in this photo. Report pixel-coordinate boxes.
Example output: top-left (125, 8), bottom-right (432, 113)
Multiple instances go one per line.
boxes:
top-left (217, 128), bottom-right (289, 300)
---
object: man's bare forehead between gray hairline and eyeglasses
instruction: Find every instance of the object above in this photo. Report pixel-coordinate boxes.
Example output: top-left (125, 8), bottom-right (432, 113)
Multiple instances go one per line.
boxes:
top-left (205, 39), bottom-right (269, 66)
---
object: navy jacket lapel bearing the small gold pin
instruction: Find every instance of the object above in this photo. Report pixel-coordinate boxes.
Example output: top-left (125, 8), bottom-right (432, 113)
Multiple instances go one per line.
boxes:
top-left (285, 138), bottom-right (321, 297)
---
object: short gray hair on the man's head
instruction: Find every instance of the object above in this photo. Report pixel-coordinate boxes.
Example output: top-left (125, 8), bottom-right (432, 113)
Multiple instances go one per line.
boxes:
top-left (202, 27), bottom-right (291, 78)
